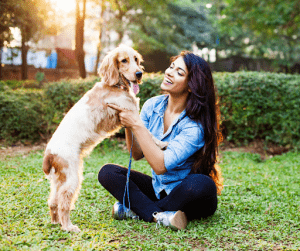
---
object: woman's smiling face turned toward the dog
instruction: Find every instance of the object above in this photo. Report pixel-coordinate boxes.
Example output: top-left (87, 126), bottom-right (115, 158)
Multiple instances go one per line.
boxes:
top-left (160, 57), bottom-right (189, 95)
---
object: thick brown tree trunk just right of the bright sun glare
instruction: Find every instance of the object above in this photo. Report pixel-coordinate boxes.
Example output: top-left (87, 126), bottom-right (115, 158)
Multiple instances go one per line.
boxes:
top-left (75, 0), bottom-right (86, 78)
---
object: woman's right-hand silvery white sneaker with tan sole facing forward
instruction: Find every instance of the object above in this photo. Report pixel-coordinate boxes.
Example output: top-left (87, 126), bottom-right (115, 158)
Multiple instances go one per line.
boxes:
top-left (153, 210), bottom-right (187, 230)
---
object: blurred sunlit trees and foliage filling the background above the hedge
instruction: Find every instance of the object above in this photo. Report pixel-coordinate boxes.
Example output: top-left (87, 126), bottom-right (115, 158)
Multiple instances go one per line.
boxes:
top-left (0, 0), bottom-right (300, 79)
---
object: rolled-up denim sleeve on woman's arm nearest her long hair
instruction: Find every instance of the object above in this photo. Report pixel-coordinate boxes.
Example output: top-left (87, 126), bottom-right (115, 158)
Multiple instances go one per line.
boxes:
top-left (164, 125), bottom-right (204, 171)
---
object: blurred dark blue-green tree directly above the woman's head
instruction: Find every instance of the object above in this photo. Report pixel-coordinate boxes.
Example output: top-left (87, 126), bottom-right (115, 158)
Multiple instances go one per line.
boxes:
top-left (132, 1), bottom-right (213, 70)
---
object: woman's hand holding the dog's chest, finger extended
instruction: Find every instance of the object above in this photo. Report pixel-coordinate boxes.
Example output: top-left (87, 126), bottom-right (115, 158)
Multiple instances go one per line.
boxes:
top-left (107, 104), bottom-right (142, 128)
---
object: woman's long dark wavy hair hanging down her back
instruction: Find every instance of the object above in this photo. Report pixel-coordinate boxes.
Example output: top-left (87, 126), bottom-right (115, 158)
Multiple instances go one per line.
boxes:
top-left (171, 51), bottom-right (223, 194)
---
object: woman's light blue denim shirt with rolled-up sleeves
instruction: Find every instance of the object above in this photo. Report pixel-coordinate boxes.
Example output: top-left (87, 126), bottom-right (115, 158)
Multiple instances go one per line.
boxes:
top-left (140, 95), bottom-right (204, 199)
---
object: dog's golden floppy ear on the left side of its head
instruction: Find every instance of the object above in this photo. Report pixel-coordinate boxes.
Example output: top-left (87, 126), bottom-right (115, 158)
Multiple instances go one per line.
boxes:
top-left (98, 51), bottom-right (119, 86)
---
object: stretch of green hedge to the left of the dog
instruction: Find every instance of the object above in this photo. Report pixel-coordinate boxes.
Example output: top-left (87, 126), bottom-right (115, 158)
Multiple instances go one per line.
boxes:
top-left (0, 78), bottom-right (99, 143)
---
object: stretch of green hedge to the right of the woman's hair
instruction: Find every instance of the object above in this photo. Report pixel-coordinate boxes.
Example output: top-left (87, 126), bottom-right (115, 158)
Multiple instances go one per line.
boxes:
top-left (214, 72), bottom-right (300, 146)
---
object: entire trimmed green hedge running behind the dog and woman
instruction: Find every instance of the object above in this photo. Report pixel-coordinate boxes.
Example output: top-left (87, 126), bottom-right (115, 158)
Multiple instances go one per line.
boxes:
top-left (0, 72), bottom-right (300, 147)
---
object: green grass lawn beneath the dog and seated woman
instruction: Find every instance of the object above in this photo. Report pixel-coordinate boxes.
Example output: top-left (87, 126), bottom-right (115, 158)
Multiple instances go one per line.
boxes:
top-left (0, 140), bottom-right (300, 250)
